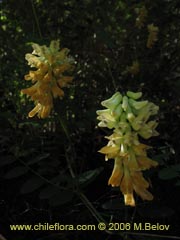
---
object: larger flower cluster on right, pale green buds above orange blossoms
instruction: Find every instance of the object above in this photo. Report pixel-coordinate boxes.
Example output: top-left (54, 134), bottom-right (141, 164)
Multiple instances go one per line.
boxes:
top-left (97, 91), bottom-right (159, 206)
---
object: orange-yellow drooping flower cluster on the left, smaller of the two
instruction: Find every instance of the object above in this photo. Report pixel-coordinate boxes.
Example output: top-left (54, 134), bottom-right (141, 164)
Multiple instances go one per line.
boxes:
top-left (22, 40), bottom-right (74, 118)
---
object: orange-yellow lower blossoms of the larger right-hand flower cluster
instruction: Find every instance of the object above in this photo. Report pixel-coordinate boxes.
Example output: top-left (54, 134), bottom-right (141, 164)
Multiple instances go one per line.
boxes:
top-left (99, 139), bottom-right (157, 206)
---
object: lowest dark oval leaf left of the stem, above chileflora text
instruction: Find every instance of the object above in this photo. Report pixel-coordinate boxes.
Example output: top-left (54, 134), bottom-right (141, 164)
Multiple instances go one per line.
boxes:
top-left (49, 190), bottom-right (74, 207)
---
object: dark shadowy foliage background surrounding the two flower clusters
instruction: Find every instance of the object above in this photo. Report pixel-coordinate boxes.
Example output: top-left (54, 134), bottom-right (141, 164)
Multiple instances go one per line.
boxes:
top-left (0, 0), bottom-right (180, 240)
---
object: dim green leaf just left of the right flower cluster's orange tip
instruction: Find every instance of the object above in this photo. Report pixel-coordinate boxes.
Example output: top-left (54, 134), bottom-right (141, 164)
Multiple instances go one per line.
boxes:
top-left (78, 167), bottom-right (103, 187)
